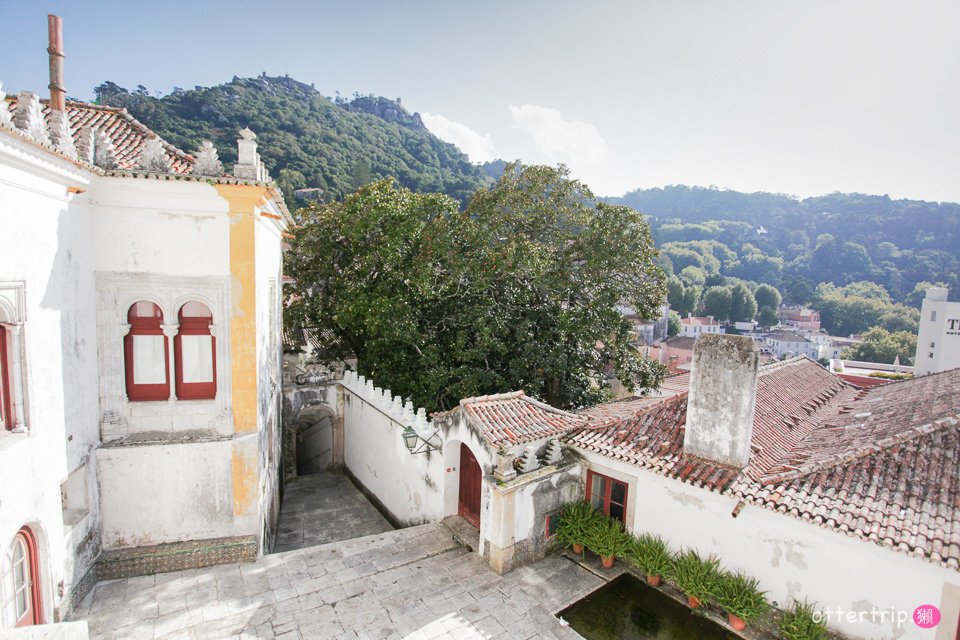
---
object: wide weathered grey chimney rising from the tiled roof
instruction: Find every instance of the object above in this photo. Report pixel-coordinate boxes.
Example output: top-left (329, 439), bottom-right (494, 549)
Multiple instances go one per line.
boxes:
top-left (683, 333), bottom-right (759, 469)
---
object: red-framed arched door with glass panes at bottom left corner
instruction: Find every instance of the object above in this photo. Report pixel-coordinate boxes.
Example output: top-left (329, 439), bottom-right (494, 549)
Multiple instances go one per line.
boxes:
top-left (3, 527), bottom-right (43, 627)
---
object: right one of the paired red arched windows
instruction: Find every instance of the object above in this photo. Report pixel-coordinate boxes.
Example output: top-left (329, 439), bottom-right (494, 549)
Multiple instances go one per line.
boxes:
top-left (173, 302), bottom-right (217, 400)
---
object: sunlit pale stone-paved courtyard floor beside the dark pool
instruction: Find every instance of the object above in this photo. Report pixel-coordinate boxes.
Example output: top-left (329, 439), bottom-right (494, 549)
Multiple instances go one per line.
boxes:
top-left (73, 524), bottom-right (602, 640)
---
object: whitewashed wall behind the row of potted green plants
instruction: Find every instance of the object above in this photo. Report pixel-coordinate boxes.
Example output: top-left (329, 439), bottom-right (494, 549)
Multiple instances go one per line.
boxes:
top-left (584, 452), bottom-right (960, 640)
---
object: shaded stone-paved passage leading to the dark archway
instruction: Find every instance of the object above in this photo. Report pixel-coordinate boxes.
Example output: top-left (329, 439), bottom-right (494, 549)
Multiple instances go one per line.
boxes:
top-left (273, 473), bottom-right (393, 552)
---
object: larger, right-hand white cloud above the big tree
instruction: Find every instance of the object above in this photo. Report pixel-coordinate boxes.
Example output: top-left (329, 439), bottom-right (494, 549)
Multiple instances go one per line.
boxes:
top-left (509, 104), bottom-right (607, 164)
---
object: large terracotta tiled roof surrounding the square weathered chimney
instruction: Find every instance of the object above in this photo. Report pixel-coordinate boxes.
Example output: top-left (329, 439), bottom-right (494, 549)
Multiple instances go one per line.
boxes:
top-left (567, 357), bottom-right (960, 569)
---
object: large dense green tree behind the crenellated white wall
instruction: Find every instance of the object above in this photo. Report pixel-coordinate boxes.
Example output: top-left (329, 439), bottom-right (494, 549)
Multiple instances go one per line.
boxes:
top-left (286, 165), bottom-right (666, 410)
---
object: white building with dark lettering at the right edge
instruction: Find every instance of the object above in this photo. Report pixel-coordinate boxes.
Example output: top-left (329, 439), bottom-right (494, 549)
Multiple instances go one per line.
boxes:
top-left (913, 287), bottom-right (960, 376)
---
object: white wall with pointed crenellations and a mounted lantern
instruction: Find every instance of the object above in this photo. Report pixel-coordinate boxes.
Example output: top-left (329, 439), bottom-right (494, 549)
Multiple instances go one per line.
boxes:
top-left (340, 371), bottom-right (445, 526)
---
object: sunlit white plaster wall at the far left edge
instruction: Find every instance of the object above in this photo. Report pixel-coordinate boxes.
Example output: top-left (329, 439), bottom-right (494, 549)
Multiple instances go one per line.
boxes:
top-left (0, 136), bottom-right (100, 627)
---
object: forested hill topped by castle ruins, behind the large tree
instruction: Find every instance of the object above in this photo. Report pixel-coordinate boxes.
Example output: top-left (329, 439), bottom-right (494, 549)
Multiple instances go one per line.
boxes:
top-left (96, 76), bottom-right (491, 202)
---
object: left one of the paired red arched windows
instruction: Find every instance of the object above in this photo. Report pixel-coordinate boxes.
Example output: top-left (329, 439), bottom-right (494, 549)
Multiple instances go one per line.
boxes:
top-left (123, 301), bottom-right (170, 400)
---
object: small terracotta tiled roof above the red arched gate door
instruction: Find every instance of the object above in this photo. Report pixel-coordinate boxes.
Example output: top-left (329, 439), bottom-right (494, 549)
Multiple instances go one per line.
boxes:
top-left (448, 391), bottom-right (587, 449)
